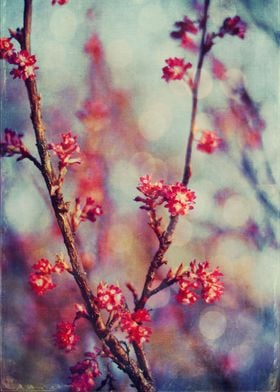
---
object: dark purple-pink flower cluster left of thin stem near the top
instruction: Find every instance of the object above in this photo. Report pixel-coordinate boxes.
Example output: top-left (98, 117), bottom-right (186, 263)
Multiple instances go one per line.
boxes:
top-left (170, 16), bottom-right (198, 51)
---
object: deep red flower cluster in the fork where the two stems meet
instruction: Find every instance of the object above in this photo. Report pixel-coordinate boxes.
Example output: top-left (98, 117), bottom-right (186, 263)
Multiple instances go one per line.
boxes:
top-left (120, 309), bottom-right (152, 344)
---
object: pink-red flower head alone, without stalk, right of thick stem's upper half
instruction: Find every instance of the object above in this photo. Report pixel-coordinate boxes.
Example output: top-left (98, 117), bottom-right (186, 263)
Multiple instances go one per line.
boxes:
top-left (48, 132), bottom-right (81, 168)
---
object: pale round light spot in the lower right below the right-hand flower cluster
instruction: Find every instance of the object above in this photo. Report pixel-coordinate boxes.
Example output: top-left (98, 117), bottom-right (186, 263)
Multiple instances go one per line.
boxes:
top-left (199, 310), bottom-right (227, 340)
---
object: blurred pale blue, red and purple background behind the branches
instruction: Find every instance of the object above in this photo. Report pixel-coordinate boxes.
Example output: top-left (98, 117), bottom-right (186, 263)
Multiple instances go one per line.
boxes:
top-left (1, 0), bottom-right (280, 391)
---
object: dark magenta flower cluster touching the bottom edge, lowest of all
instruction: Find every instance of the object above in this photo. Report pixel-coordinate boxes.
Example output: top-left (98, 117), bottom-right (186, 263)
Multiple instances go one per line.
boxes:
top-left (70, 353), bottom-right (101, 392)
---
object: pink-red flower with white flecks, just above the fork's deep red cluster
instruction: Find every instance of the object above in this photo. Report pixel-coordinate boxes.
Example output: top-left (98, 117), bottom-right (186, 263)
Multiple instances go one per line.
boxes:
top-left (97, 282), bottom-right (125, 312)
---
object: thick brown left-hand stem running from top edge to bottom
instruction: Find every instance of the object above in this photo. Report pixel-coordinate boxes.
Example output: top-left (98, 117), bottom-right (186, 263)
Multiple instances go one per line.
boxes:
top-left (15, 0), bottom-right (154, 392)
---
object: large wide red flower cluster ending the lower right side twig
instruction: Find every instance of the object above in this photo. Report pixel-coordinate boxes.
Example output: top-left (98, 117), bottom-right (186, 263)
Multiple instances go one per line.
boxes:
top-left (177, 260), bottom-right (224, 304)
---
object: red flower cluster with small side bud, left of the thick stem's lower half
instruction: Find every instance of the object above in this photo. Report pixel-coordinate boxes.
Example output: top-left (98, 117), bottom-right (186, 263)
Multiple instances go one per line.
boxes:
top-left (29, 255), bottom-right (69, 295)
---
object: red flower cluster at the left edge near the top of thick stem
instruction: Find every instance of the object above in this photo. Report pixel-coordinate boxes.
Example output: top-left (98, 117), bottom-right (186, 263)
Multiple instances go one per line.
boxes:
top-left (0, 37), bottom-right (38, 80)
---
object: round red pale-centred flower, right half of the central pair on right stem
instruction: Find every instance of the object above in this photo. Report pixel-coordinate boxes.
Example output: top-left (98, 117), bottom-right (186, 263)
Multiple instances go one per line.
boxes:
top-left (164, 182), bottom-right (196, 216)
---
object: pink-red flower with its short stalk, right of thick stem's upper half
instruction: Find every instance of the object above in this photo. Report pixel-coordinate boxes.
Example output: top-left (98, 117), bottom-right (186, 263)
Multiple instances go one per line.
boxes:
top-left (48, 132), bottom-right (81, 194)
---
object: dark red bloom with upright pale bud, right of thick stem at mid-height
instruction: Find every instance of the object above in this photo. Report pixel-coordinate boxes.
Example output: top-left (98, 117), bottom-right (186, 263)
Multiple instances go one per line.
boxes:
top-left (70, 197), bottom-right (103, 232)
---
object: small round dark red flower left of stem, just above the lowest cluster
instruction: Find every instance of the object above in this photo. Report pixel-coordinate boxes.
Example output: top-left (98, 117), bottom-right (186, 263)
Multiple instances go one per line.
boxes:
top-left (54, 321), bottom-right (79, 353)
